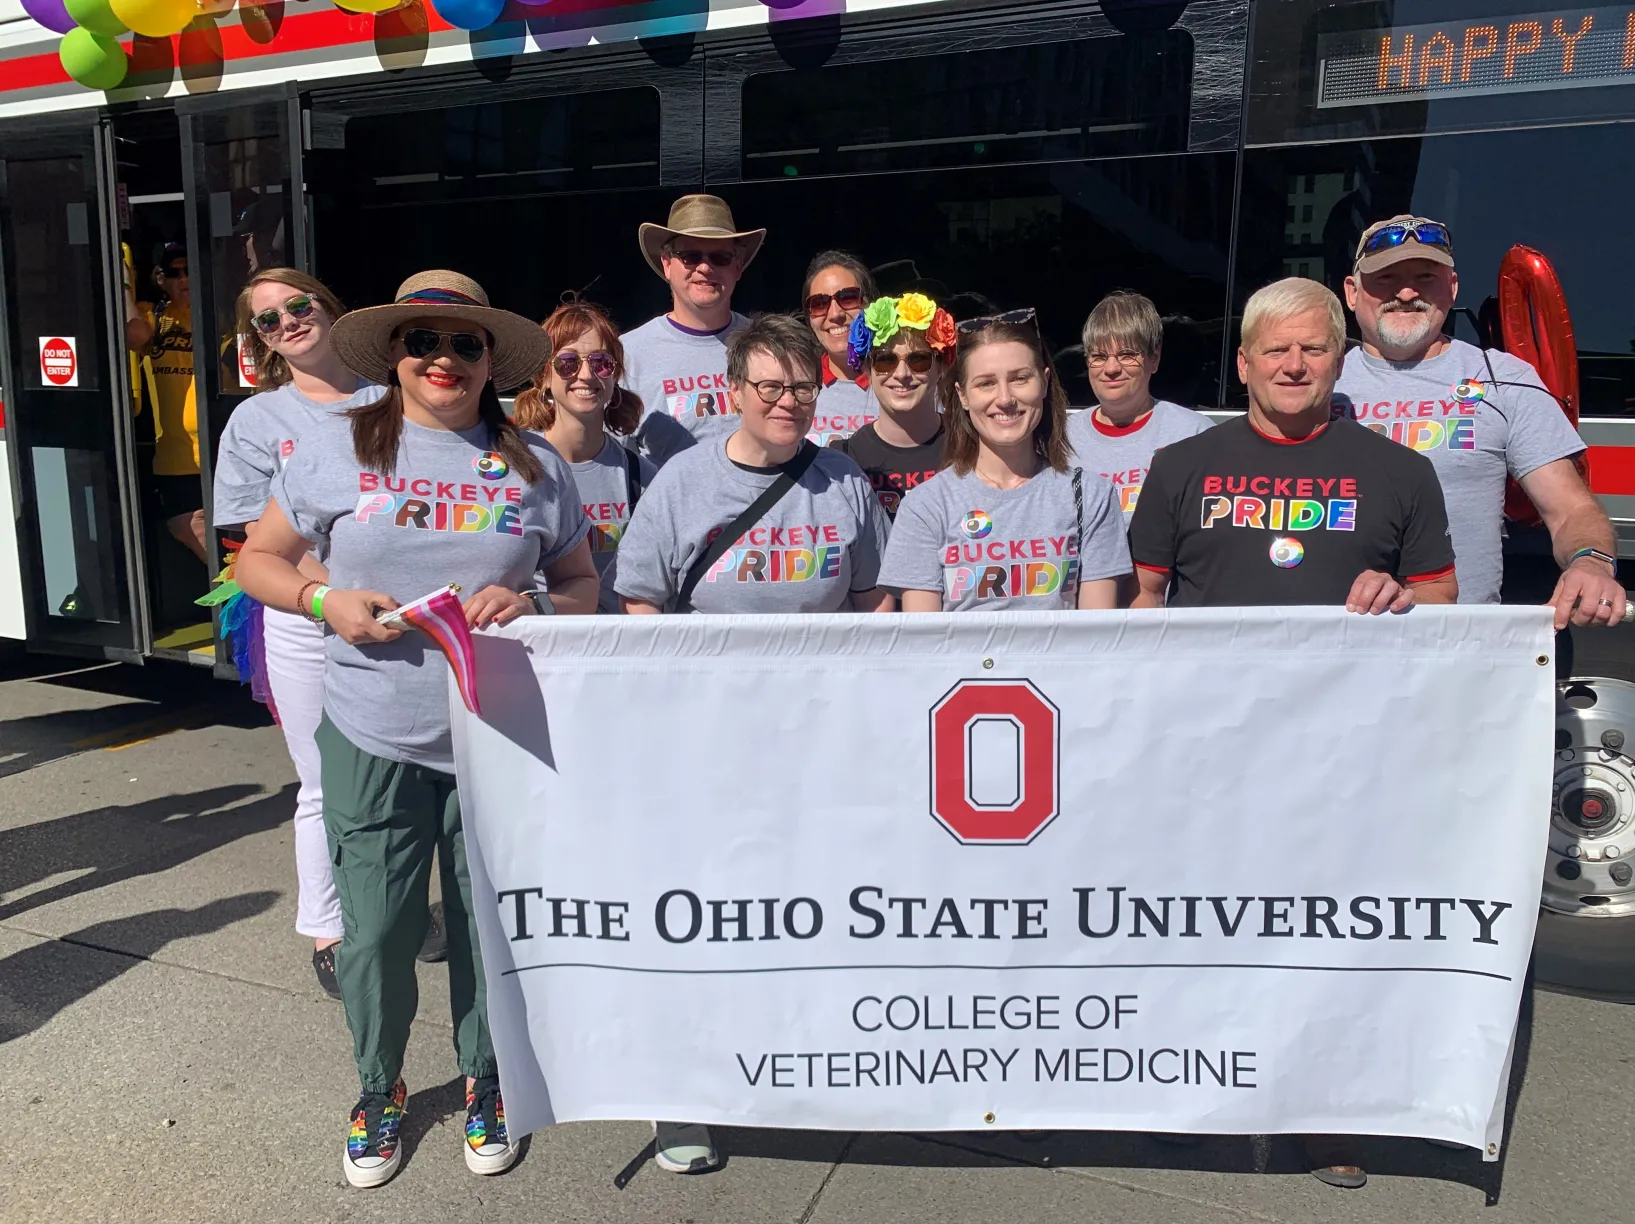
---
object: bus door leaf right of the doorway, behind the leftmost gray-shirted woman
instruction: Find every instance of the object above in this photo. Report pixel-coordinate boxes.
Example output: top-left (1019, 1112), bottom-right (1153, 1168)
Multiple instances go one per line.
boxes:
top-left (177, 87), bottom-right (309, 675)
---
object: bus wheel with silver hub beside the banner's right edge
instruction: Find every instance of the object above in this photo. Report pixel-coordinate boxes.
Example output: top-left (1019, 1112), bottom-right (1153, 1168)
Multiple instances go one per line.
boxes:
top-left (1534, 677), bottom-right (1635, 1000)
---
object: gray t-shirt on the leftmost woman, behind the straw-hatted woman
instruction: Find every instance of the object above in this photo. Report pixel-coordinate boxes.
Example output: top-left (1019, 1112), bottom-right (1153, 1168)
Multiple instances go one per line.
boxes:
top-left (213, 382), bottom-right (386, 528)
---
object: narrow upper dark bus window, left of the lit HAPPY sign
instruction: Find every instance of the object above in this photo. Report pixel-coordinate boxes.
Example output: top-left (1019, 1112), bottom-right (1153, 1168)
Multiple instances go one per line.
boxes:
top-left (742, 29), bottom-right (1192, 180)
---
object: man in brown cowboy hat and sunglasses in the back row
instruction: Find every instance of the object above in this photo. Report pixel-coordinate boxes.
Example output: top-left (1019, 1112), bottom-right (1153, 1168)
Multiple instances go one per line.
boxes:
top-left (623, 196), bottom-right (767, 464)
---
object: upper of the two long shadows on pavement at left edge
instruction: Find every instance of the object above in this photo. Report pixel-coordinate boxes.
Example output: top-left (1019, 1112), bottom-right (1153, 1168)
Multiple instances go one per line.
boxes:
top-left (0, 783), bottom-right (296, 922)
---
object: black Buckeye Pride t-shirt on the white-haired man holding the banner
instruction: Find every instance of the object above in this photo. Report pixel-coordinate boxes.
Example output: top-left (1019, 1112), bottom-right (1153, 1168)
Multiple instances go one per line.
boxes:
top-left (1130, 417), bottom-right (1454, 608)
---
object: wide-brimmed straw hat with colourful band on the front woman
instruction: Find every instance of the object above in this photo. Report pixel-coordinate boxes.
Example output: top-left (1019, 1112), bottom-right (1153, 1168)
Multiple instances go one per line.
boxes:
top-left (330, 270), bottom-right (551, 391)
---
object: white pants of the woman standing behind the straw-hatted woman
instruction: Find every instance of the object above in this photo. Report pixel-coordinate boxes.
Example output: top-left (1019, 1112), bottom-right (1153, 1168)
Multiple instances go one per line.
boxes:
top-left (262, 608), bottom-right (340, 940)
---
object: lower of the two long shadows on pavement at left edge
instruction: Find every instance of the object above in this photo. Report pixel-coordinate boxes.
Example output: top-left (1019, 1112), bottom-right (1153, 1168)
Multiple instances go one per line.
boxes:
top-left (0, 892), bottom-right (278, 1044)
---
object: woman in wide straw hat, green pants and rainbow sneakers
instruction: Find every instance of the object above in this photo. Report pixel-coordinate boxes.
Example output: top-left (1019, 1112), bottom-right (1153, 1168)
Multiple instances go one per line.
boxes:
top-left (237, 271), bottom-right (598, 1186)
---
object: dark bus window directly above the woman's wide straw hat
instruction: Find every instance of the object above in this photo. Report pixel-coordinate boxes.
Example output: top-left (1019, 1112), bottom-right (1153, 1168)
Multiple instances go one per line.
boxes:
top-left (306, 87), bottom-right (667, 327)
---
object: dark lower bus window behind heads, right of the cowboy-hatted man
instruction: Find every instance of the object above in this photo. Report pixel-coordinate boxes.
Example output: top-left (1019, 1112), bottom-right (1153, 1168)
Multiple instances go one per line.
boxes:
top-left (718, 154), bottom-right (1234, 407)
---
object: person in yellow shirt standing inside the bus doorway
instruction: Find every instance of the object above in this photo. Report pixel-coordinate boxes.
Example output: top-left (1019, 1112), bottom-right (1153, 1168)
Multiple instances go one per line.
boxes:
top-left (124, 243), bottom-right (206, 562)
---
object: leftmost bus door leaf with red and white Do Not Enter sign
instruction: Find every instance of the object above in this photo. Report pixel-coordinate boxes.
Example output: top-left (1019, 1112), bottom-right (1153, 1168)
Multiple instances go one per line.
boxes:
top-left (0, 111), bottom-right (150, 662)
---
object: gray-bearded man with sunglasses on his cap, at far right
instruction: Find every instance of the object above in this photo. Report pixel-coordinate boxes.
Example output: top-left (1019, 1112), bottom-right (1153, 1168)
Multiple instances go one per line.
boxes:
top-left (1334, 214), bottom-right (1635, 629)
